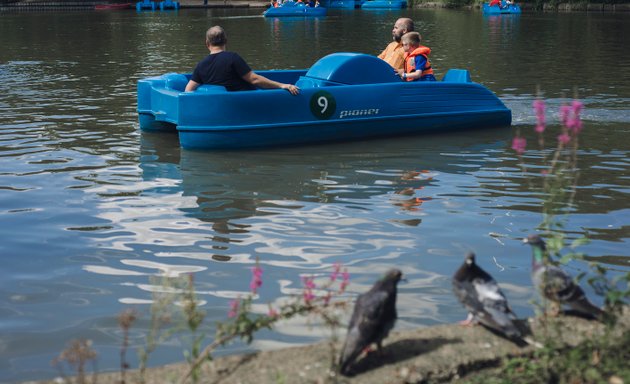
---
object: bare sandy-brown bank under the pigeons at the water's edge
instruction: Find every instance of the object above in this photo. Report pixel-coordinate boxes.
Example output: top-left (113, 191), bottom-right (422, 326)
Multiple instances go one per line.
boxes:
top-left (22, 308), bottom-right (630, 384)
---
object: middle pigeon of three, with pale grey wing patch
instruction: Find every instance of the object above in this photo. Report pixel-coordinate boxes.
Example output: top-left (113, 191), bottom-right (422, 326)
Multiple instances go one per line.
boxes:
top-left (452, 253), bottom-right (522, 342)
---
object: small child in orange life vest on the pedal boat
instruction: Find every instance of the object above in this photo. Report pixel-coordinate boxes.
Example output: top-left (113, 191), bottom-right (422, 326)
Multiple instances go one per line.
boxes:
top-left (398, 32), bottom-right (436, 81)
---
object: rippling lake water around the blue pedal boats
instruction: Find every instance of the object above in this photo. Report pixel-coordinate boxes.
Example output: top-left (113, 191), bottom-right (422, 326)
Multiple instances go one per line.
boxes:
top-left (0, 9), bottom-right (630, 382)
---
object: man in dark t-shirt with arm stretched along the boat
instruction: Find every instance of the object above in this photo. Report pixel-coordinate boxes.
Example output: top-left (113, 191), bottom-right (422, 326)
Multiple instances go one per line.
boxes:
top-left (186, 25), bottom-right (300, 95)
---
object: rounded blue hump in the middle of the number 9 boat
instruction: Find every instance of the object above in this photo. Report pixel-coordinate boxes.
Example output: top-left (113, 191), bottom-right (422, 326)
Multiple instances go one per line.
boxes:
top-left (306, 52), bottom-right (402, 85)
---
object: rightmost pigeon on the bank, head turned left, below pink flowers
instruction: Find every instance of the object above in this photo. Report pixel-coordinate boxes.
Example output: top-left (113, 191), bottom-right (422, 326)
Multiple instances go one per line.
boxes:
top-left (523, 235), bottom-right (604, 320)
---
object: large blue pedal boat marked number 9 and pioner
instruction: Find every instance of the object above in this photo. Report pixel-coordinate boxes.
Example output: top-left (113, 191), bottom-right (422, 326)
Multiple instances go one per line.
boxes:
top-left (138, 53), bottom-right (512, 149)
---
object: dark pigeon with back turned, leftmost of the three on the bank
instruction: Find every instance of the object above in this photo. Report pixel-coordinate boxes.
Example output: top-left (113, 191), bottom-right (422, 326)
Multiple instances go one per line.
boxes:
top-left (339, 269), bottom-right (402, 375)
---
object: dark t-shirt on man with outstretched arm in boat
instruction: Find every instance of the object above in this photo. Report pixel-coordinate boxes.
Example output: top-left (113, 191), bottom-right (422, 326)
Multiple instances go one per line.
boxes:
top-left (190, 51), bottom-right (256, 91)
